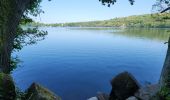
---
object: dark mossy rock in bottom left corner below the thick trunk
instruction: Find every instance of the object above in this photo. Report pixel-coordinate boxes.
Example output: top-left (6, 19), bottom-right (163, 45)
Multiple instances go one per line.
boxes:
top-left (0, 73), bottom-right (16, 100)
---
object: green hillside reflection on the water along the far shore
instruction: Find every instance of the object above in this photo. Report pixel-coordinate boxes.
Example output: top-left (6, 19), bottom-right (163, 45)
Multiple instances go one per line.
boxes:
top-left (71, 27), bottom-right (170, 41)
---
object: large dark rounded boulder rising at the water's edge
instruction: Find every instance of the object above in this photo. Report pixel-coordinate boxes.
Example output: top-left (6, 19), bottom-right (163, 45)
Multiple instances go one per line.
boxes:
top-left (109, 72), bottom-right (139, 100)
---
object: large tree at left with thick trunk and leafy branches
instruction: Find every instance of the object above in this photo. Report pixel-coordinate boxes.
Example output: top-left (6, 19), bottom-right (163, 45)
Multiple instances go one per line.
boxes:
top-left (0, 0), bottom-right (46, 73)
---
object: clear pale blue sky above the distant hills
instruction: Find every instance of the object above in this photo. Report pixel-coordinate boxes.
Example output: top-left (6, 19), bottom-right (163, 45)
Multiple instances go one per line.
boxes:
top-left (33, 0), bottom-right (156, 23)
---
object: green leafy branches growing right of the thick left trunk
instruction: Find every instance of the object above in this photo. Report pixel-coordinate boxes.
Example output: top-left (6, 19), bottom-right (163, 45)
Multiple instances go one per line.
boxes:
top-left (10, 0), bottom-right (47, 71)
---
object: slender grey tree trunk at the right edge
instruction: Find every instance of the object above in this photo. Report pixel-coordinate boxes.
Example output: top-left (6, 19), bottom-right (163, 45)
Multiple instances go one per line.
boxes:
top-left (159, 38), bottom-right (170, 88)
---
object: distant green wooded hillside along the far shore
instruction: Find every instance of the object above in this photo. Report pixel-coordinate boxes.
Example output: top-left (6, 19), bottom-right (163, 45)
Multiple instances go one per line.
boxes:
top-left (30, 13), bottom-right (170, 28)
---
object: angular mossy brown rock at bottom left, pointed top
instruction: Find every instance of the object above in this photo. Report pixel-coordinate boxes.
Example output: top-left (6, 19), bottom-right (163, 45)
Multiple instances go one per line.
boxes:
top-left (25, 83), bottom-right (61, 100)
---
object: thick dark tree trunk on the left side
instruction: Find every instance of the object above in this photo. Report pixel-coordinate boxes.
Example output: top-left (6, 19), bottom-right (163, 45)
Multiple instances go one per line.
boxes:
top-left (0, 0), bottom-right (31, 73)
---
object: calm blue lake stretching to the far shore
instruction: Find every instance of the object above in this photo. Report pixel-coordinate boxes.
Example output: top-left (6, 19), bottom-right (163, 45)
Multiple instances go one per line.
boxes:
top-left (12, 27), bottom-right (169, 100)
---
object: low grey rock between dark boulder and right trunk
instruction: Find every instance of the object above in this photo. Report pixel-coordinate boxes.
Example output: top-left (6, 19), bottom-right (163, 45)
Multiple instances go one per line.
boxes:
top-left (135, 84), bottom-right (159, 100)
